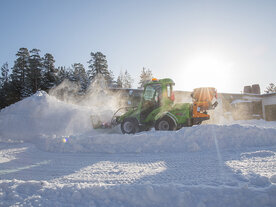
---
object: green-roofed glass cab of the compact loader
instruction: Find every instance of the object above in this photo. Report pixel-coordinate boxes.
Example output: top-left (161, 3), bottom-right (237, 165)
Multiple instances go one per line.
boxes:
top-left (140, 79), bottom-right (174, 122)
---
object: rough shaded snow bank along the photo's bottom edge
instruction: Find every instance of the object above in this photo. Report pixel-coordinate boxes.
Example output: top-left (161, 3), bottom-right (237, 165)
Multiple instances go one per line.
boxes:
top-left (0, 180), bottom-right (276, 207)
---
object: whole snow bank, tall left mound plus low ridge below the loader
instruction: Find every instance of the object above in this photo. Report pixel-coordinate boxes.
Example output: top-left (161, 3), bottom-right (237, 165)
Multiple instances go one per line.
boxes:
top-left (0, 92), bottom-right (276, 153)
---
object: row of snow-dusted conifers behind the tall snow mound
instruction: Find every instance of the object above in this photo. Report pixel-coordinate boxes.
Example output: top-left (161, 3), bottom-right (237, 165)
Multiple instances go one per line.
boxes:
top-left (0, 48), bottom-right (152, 109)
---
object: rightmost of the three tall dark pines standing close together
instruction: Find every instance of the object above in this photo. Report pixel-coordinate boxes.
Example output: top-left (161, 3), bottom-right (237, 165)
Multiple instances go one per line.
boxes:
top-left (41, 53), bottom-right (58, 91)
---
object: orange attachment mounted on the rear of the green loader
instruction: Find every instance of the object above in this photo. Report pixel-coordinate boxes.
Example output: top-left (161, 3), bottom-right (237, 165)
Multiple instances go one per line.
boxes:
top-left (191, 87), bottom-right (218, 120)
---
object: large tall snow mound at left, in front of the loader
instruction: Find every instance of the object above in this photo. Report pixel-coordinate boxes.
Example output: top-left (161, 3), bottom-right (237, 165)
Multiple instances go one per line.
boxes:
top-left (0, 91), bottom-right (91, 140)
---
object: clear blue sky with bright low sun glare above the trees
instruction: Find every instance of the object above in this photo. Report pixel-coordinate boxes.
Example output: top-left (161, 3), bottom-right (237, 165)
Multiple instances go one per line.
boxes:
top-left (0, 0), bottom-right (276, 93)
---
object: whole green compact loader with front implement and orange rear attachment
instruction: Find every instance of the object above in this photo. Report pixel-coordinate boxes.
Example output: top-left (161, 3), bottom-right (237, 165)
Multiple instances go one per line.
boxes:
top-left (91, 78), bottom-right (217, 134)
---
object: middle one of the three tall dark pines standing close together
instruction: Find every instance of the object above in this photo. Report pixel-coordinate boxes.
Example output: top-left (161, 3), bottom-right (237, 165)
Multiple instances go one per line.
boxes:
top-left (26, 49), bottom-right (42, 96)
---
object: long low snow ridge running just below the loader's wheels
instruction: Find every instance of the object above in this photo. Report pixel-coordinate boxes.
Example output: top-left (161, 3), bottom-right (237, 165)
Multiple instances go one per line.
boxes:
top-left (38, 124), bottom-right (276, 153)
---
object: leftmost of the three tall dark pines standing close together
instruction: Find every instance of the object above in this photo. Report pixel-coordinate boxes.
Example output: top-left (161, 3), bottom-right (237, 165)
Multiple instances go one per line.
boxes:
top-left (11, 48), bottom-right (30, 102)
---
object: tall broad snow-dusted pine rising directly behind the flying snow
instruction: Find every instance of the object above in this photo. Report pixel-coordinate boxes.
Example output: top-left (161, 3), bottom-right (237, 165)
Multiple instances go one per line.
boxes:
top-left (88, 52), bottom-right (114, 85)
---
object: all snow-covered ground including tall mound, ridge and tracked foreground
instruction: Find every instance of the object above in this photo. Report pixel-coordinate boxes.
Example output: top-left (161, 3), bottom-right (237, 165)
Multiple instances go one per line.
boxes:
top-left (0, 92), bottom-right (276, 207)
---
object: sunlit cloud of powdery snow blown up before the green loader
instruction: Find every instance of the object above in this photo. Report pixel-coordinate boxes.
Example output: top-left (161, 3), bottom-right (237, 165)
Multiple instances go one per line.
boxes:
top-left (49, 74), bottom-right (127, 122)
